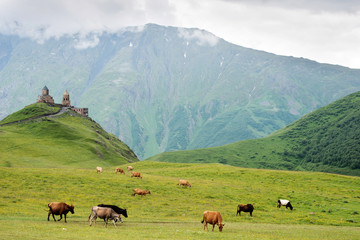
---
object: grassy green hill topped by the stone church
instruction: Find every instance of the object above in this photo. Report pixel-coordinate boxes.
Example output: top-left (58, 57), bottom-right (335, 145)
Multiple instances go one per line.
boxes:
top-left (0, 103), bottom-right (139, 168)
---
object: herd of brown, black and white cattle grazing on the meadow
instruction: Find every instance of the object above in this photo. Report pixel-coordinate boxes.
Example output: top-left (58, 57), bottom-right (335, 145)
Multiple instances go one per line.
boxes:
top-left (48, 166), bottom-right (293, 232)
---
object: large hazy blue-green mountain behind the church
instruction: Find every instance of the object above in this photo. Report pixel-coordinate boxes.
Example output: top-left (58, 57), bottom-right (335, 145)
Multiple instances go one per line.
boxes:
top-left (0, 24), bottom-right (360, 159)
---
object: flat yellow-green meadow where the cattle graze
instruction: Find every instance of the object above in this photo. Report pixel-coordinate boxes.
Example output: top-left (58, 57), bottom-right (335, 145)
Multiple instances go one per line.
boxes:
top-left (0, 161), bottom-right (360, 239)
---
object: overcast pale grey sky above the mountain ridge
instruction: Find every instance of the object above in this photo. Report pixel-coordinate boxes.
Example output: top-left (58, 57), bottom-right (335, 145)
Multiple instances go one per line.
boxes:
top-left (0, 0), bottom-right (360, 69)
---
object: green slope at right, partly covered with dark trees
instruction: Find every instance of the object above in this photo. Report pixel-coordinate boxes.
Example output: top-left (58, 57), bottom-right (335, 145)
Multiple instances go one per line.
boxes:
top-left (149, 92), bottom-right (360, 176)
